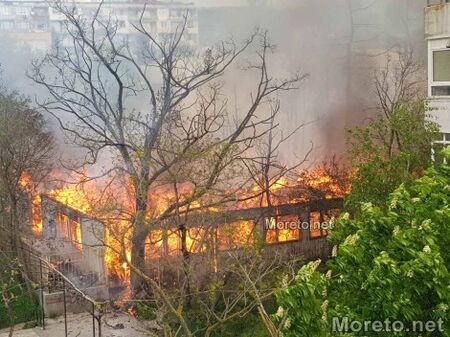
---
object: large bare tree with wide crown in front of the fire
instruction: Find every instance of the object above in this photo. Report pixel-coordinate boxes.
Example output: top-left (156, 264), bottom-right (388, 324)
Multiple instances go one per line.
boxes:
top-left (30, 2), bottom-right (303, 306)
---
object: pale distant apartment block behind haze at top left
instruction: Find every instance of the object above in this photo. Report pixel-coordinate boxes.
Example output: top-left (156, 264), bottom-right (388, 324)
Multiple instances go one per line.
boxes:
top-left (0, 0), bottom-right (198, 52)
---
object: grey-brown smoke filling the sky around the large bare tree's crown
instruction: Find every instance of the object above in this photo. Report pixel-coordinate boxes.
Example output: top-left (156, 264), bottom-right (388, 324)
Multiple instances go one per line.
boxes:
top-left (0, 0), bottom-right (426, 164)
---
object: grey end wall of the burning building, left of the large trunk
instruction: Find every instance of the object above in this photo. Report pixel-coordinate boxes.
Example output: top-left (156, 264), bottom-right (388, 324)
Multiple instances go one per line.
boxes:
top-left (24, 195), bottom-right (109, 299)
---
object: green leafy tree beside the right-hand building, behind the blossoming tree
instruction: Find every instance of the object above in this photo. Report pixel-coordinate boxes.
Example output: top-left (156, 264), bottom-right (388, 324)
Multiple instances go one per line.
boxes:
top-left (346, 101), bottom-right (438, 211)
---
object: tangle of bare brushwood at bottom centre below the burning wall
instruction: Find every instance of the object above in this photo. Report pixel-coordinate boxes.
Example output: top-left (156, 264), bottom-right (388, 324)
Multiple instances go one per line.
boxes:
top-left (135, 247), bottom-right (302, 337)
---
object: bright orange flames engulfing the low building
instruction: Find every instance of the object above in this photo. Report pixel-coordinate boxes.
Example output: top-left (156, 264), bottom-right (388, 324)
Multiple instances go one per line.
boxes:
top-left (21, 160), bottom-right (351, 282)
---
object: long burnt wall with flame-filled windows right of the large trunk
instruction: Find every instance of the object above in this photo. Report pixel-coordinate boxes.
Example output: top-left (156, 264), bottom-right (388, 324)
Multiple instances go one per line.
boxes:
top-left (146, 198), bottom-right (343, 286)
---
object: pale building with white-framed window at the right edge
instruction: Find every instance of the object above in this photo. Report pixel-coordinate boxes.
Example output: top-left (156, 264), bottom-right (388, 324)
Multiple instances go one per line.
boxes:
top-left (425, 0), bottom-right (450, 158)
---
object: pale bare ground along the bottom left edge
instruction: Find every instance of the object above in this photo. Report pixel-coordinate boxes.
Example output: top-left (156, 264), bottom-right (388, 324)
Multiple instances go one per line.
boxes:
top-left (0, 313), bottom-right (148, 337)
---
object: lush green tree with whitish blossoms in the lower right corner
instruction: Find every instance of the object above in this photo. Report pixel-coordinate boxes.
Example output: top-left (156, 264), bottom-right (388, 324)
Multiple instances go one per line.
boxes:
top-left (277, 149), bottom-right (450, 336)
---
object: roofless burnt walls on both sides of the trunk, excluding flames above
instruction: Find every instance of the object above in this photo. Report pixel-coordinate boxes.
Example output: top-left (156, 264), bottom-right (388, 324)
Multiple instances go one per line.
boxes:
top-left (24, 196), bottom-right (343, 300)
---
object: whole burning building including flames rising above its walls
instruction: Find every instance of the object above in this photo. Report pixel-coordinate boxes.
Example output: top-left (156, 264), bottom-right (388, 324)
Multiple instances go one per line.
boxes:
top-left (20, 163), bottom-right (349, 308)
